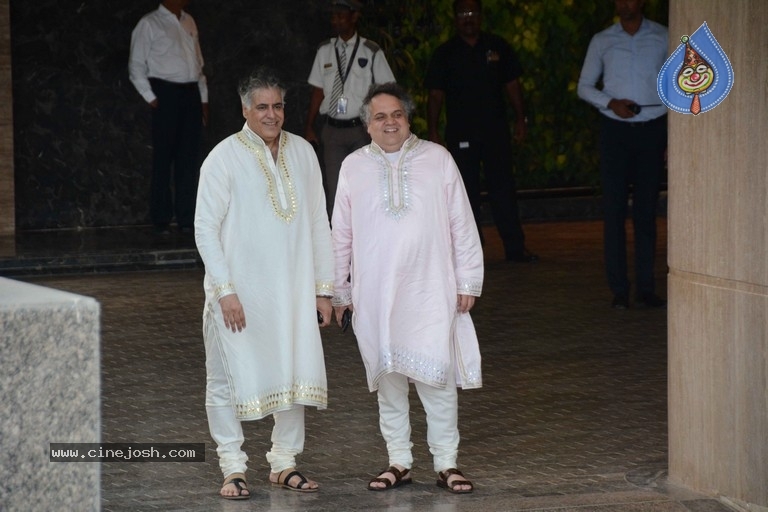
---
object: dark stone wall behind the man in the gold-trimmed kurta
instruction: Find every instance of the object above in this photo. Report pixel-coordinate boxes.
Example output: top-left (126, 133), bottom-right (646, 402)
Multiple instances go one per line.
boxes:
top-left (10, 0), bottom-right (330, 231)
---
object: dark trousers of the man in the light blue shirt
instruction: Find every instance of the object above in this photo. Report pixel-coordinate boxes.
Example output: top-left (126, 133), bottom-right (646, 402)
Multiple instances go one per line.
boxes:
top-left (599, 116), bottom-right (667, 296)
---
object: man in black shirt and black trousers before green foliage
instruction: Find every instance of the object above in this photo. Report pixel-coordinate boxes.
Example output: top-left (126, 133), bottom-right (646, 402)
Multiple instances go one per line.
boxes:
top-left (425, 0), bottom-right (538, 263)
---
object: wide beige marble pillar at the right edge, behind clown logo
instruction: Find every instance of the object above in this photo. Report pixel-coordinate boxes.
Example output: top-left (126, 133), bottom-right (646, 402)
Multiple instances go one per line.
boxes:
top-left (668, 0), bottom-right (768, 510)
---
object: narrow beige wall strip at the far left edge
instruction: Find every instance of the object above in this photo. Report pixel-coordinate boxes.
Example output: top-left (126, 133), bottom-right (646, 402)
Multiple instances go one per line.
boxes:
top-left (0, 0), bottom-right (16, 235)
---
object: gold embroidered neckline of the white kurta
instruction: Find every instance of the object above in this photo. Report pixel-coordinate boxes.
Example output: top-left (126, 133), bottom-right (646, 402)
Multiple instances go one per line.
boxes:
top-left (237, 125), bottom-right (298, 224)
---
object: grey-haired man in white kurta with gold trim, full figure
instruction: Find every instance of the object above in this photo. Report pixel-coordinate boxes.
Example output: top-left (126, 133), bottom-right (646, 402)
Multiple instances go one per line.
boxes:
top-left (195, 66), bottom-right (333, 498)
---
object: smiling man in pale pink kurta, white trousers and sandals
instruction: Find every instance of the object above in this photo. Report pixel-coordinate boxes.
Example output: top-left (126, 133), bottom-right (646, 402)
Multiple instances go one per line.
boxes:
top-left (333, 83), bottom-right (483, 492)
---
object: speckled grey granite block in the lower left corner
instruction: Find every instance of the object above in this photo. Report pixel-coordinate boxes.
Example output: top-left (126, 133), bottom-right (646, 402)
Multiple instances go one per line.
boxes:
top-left (0, 278), bottom-right (101, 511)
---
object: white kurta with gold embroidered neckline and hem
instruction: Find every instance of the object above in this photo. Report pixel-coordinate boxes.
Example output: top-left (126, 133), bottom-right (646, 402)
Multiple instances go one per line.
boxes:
top-left (195, 125), bottom-right (333, 420)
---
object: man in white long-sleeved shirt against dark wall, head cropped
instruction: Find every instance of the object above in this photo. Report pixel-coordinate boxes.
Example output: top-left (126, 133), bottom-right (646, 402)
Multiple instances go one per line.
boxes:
top-left (128, 0), bottom-right (208, 234)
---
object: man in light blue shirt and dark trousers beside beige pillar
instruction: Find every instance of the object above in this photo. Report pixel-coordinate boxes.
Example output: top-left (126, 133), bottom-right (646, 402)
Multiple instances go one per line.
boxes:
top-left (578, 0), bottom-right (668, 309)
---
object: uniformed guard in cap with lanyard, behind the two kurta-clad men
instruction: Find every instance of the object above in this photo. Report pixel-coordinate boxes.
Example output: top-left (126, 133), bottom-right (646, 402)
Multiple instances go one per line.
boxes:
top-left (304, 0), bottom-right (395, 217)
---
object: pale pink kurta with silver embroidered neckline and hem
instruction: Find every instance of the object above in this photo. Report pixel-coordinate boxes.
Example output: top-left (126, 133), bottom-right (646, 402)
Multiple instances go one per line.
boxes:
top-left (333, 135), bottom-right (483, 391)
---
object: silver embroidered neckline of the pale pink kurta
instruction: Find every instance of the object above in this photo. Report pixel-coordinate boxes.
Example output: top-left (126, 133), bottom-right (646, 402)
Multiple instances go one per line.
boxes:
top-left (365, 134), bottom-right (421, 219)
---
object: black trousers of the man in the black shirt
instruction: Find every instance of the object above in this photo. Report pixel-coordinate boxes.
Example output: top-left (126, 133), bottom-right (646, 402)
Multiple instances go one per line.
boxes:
top-left (448, 136), bottom-right (525, 257)
